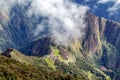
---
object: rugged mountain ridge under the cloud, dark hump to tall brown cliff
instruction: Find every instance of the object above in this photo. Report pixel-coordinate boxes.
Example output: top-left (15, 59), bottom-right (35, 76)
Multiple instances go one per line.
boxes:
top-left (20, 13), bottom-right (120, 80)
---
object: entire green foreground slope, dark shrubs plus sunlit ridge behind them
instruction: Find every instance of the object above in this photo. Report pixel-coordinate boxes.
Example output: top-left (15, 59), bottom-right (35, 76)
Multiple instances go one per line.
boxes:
top-left (0, 48), bottom-right (109, 80)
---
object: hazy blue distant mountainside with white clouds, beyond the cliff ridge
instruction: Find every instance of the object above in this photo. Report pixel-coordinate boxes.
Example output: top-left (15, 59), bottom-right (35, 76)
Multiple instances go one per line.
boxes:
top-left (75, 0), bottom-right (120, 22)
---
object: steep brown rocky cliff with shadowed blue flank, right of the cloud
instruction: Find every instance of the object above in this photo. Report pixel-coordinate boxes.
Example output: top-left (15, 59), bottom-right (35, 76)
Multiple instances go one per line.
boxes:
top-left (82, 14), bottom-right (120, 79)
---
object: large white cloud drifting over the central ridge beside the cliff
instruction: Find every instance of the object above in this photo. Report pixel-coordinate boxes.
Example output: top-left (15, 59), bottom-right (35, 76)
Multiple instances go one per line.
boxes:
top-left (28, 0), bottom-right (88, 46)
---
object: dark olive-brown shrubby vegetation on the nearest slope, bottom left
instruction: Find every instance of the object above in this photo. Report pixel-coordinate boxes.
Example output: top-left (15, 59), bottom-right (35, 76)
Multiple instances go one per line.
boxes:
top-left (0, 56), bottom-right (82, 80)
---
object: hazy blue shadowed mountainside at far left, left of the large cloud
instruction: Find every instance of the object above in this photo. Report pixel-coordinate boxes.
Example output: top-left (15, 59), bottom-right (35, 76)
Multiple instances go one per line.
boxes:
top-left (0, 5), bottom-right (34, 50)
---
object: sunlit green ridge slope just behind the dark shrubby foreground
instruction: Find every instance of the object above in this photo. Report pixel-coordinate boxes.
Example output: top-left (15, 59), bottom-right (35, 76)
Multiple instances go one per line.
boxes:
top-left (2, 49), bottom-right (110, 80)
